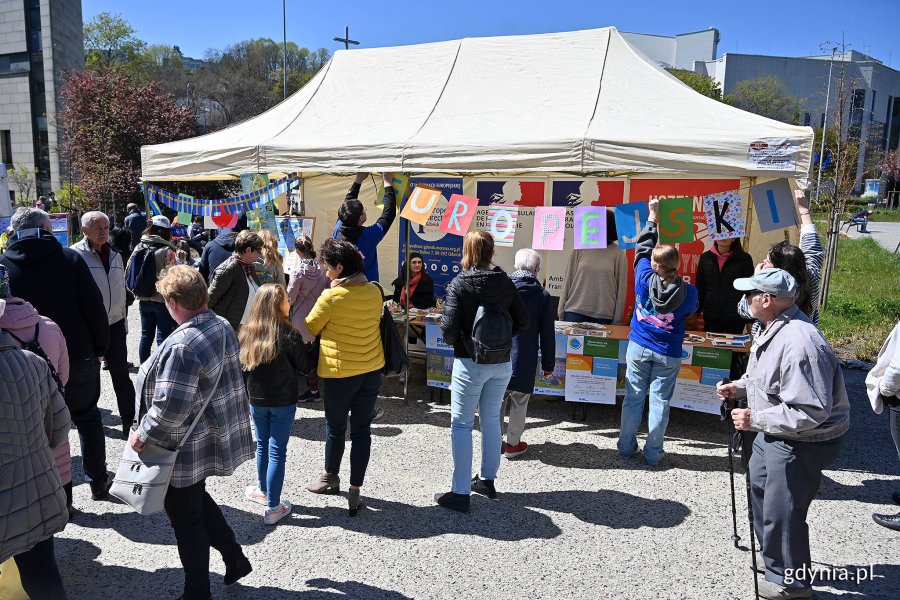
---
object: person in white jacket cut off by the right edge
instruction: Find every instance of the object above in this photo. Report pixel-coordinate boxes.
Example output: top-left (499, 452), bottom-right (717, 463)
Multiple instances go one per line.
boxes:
top-left (866, 323), bottom-right (900, 531)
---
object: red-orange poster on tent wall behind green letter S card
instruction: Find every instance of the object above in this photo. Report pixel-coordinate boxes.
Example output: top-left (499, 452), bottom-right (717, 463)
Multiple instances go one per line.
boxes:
top-left (624, 179), bottom-right (741, 323)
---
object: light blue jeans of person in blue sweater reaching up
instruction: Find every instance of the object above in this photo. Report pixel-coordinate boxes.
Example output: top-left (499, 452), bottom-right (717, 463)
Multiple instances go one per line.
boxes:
top-left (619, 341), bottom-right (681, 465)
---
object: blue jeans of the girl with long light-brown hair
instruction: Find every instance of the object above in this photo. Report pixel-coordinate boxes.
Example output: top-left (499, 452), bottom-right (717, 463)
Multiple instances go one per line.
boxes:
top-left (250, 404), bottom-right (297, 508)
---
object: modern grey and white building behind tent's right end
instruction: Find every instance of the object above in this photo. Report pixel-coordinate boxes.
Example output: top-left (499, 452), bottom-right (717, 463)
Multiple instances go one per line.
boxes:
top-left (693, 50), bottom-right (900, 191)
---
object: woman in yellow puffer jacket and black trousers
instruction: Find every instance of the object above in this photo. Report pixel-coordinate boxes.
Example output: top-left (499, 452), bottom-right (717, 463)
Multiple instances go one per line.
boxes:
top-left (306, 239), bottom-right (384, 516)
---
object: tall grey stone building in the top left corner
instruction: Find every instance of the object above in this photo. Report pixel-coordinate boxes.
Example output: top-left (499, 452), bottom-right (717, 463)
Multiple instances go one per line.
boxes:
top-left (0, 0), bottom-right (84, 204)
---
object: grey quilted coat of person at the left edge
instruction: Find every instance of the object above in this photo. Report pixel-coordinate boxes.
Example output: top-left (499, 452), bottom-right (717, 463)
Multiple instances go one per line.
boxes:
top-left (0, 332), bottom-right (71, 563)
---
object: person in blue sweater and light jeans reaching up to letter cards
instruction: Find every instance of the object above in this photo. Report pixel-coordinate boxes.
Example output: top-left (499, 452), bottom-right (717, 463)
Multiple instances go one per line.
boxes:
top-left (618, 200), bottom-right (697, 466)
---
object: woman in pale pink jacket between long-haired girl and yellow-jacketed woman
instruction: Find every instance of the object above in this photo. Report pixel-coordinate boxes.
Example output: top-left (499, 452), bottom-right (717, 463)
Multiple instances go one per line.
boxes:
top-left (288, 235), bottom-right (330, 404)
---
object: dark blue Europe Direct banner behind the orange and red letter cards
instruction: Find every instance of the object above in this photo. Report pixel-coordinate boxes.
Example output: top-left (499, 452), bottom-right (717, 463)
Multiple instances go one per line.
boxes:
top-left (396, 177), bottom-right (463, 298)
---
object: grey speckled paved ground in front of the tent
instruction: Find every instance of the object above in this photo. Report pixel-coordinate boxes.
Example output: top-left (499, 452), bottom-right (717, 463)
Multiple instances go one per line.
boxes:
top-left (56, 310), bottom-right (900, 600)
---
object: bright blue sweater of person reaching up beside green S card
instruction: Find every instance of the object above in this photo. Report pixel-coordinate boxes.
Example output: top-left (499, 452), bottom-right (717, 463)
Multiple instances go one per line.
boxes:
top-left (628, 221), bottom-right (697, 358)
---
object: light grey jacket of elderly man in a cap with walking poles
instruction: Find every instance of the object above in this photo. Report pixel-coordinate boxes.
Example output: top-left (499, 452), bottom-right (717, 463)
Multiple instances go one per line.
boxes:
top-left (735, 305), bottom-right (850, 442)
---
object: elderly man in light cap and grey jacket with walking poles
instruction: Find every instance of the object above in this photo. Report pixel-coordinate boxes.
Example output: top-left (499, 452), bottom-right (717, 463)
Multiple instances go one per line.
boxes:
top-left (717, 269), bottom-right (850, 599)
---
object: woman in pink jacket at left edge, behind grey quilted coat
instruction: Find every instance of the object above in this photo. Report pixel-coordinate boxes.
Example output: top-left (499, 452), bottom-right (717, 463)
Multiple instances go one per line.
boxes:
top-left (0, 288), bottom-right (72, 520)
